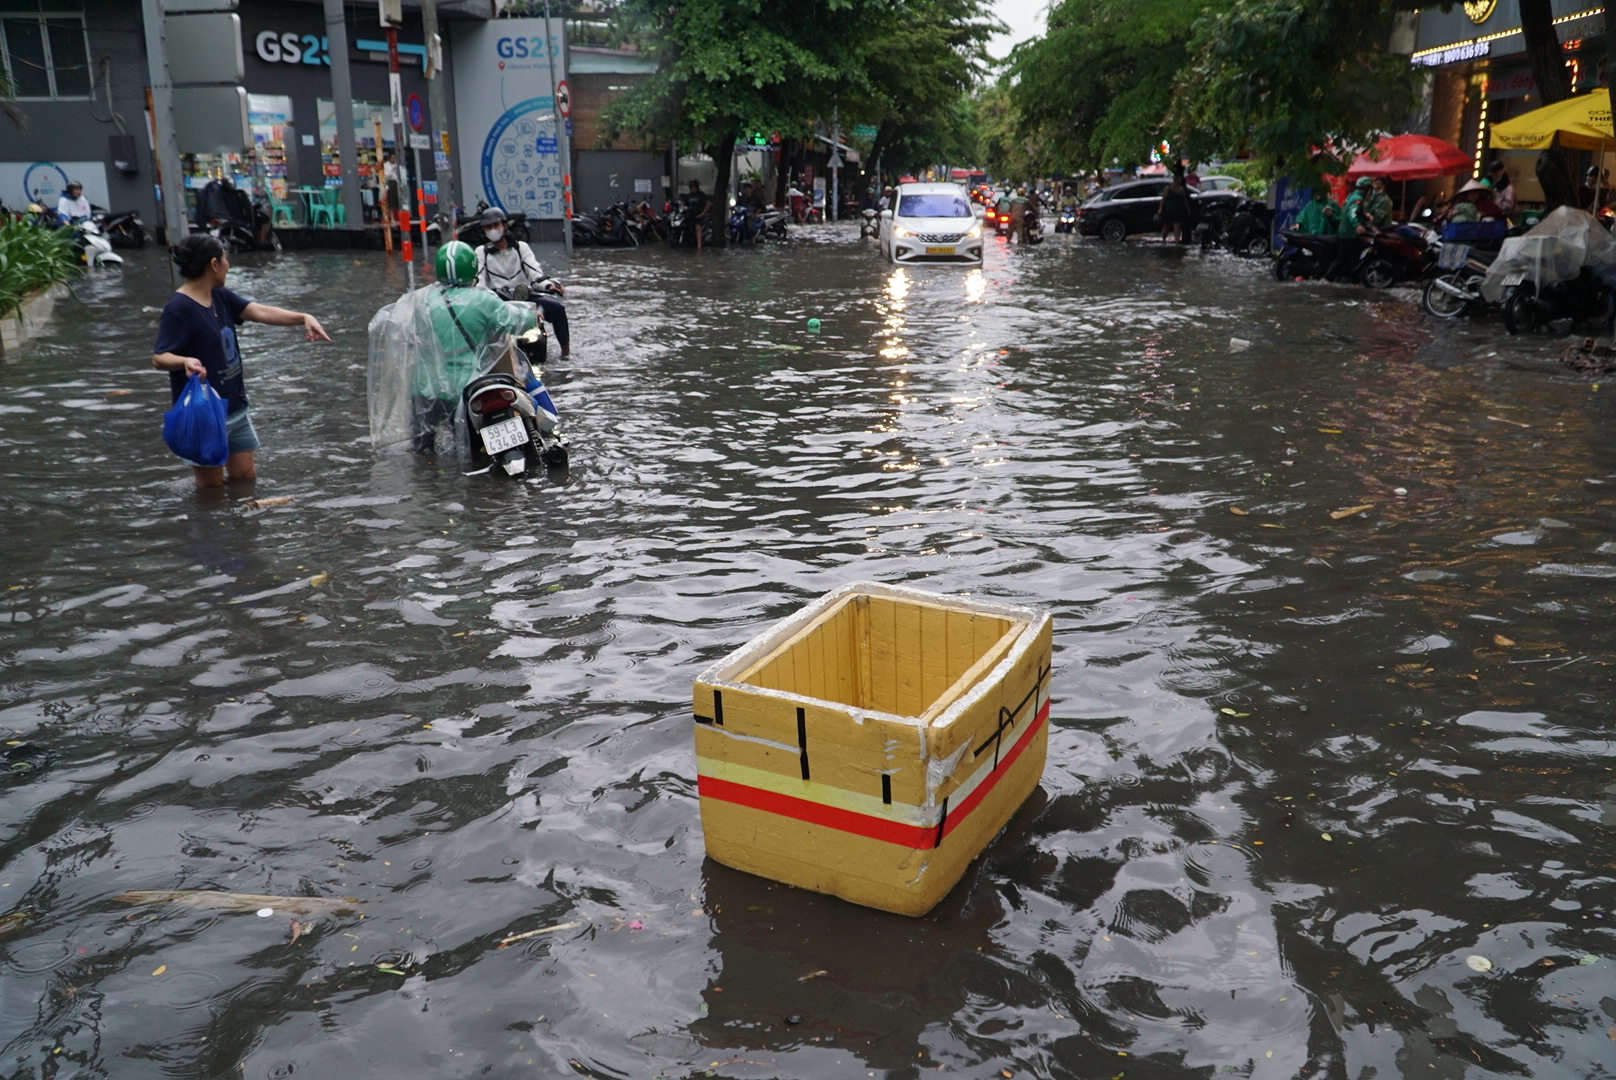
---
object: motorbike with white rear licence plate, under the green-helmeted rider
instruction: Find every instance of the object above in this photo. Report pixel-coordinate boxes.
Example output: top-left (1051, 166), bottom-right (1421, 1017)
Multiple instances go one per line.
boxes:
top-left (461, 333), bottom-right (567, 477)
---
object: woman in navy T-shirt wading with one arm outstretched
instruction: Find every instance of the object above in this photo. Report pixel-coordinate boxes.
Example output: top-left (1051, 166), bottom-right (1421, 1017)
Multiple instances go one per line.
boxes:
top-left (152, 233), bottom-right (331, 488)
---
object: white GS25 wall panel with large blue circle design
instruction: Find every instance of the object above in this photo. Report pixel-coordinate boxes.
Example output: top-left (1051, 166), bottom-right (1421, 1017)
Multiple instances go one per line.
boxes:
top-left (454, 19), bottom-right (566, 220)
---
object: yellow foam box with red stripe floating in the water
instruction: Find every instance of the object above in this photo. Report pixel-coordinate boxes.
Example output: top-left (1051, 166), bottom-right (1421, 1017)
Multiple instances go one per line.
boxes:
top-left (695, 582), bottom-right (1052, 915)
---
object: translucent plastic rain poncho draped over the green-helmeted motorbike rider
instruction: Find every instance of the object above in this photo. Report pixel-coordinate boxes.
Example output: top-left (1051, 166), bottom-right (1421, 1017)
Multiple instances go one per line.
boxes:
top-left (367, 285), bottom-right (535, 451)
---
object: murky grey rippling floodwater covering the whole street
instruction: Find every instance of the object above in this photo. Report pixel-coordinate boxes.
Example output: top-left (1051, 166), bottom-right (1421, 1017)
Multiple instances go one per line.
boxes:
top-left (0, 228), bottom-right (1616, 1080)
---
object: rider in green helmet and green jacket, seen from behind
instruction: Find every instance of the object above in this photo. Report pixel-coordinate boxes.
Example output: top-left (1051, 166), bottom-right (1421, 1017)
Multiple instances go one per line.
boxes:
top-left (410, 239), bottom-right (535, 453)
